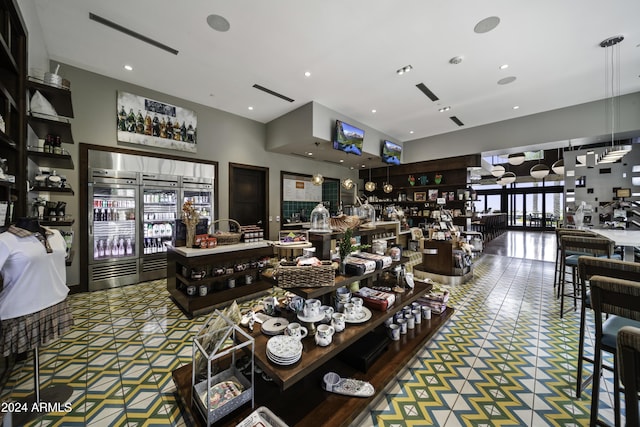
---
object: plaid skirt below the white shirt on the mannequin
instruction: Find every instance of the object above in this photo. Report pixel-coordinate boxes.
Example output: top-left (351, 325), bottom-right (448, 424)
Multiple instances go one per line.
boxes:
top-left (0, 299), bottom-right (73, 357)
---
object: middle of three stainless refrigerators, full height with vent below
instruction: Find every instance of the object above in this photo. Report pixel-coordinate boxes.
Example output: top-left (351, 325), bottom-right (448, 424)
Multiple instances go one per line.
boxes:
top-left (140, 173), bottom-right (179, 281)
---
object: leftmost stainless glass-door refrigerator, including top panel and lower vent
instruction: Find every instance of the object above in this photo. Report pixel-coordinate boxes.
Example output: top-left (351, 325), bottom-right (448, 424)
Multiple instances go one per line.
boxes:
top-left (88, 169), bottom-right (138, 291)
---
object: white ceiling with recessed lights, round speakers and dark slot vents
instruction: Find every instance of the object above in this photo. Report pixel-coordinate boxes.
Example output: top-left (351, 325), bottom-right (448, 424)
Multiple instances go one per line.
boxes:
top-left (28, 0), bottom-right (640, 166)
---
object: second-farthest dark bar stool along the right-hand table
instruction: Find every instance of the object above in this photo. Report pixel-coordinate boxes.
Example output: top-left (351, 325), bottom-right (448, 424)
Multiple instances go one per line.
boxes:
top-left (558, 234), bottom-right (619, 318)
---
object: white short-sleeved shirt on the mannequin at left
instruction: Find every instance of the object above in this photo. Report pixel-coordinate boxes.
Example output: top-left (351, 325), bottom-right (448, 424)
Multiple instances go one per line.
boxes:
top-left (0, 229), bottom-right (69, 320)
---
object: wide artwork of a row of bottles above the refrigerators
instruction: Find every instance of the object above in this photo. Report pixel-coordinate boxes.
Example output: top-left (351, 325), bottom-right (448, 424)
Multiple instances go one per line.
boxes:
top-left (116, 91), bottom-right (198, 153)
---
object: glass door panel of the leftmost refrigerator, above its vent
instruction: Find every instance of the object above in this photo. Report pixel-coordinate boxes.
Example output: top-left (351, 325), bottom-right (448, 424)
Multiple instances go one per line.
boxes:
top-left (89, 184), bottom-right (137, 261)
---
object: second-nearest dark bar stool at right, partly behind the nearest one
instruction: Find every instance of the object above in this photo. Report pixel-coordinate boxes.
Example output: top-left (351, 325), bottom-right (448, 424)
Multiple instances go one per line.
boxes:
top-left (589, 276), bottom-right (640, 427)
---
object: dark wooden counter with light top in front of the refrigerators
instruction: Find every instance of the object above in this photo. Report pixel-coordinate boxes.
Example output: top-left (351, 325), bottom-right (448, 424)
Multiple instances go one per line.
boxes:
top-left (167, 241), bottom-right (274, 317)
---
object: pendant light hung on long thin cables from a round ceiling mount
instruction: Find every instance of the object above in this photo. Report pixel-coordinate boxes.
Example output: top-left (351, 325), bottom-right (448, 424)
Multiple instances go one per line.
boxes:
top-left (598, 36), bottom-right (632, 163)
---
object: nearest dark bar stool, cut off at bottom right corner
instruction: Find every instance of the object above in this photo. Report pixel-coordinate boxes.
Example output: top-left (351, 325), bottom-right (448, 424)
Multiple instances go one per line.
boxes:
top-left (617, 326), bottom-right (640, 426)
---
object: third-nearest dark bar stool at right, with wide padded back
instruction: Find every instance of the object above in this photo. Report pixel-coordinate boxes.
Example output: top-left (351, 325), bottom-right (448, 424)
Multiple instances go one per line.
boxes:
top-left (576, 256), bottom-right (640, 398)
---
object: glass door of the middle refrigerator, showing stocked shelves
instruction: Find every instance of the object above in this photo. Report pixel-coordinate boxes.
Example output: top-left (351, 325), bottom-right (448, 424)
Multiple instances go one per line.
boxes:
top-left (142, 187), bottom-right (178, 256)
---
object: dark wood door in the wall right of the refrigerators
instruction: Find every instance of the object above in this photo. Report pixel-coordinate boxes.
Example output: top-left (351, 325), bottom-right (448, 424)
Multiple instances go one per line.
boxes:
top-left (229, 163), bottom-right (269, 238)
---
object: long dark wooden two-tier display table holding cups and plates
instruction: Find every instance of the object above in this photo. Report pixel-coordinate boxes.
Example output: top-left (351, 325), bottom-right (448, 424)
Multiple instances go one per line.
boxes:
top-left (173, 282), bottom-right (453, 426)
